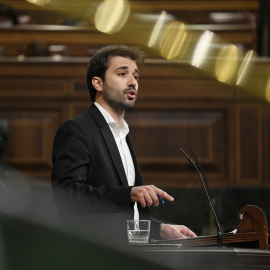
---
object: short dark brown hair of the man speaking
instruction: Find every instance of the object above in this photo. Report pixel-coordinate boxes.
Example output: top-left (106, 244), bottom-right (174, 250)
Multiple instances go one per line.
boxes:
top-left (86, 45), bottom-right (143, 102)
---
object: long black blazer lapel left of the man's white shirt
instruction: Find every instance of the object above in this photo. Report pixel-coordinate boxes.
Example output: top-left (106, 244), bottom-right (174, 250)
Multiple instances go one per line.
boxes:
top-left (89, 105), bottom-right (128, 186)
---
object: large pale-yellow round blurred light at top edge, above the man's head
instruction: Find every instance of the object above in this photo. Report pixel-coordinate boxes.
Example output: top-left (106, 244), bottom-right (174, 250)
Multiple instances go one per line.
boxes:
top-left (95, 0), bottom-right (130, 34)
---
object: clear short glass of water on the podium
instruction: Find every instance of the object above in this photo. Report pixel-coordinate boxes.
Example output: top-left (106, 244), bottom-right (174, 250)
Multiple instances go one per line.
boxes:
top-left (127, 220), bottom-right (151, 244)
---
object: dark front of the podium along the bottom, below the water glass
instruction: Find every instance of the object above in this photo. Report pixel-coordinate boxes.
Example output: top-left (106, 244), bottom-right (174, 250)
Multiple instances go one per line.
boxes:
top-left (128, 244), bottom-right (270, 270)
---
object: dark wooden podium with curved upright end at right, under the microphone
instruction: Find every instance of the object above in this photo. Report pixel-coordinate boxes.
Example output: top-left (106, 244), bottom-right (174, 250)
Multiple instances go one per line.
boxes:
top-left (129, 205), bottom-right (270, 270)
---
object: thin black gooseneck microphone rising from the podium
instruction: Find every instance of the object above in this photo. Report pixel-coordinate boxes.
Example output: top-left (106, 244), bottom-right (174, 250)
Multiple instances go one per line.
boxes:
top-left (179, 148), bottom-right (222, 247)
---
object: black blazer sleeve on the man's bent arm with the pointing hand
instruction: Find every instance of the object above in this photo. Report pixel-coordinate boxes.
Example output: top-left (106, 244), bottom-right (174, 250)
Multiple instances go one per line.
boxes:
top-left (52, 120), bottom-right (132, 214)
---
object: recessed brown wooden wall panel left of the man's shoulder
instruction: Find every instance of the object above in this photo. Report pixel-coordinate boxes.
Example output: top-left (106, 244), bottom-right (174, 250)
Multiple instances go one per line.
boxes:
top-left (1, 110), bottom-right (59, 169)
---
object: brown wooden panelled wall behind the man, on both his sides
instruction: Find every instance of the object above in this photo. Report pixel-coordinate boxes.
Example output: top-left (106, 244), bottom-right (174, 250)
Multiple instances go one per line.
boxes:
top-left (0, 58), bottom-right (270, 187)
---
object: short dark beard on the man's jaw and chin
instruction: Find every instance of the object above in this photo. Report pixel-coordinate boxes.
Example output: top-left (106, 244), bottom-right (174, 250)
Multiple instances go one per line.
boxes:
top-left (103, 82), bottom-right (137, 113)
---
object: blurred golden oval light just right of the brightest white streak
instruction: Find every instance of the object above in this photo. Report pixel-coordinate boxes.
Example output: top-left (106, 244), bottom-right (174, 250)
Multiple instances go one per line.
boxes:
top-left (215, 45), bottom-right (239, 83)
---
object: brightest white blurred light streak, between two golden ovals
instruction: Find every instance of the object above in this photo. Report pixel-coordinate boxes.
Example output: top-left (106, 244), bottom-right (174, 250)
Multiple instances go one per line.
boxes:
top-left (191, 31), bottom-right (214, 67)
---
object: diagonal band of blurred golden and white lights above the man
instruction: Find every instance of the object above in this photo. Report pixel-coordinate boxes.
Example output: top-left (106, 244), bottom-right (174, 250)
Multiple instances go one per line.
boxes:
top-left (22, 0), bottom-right (270, 101)
